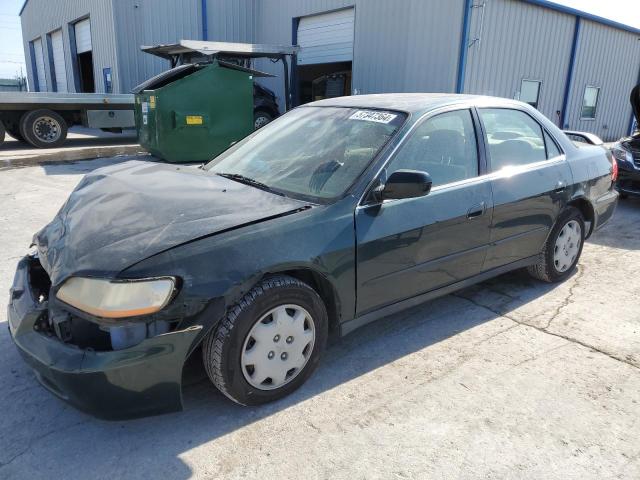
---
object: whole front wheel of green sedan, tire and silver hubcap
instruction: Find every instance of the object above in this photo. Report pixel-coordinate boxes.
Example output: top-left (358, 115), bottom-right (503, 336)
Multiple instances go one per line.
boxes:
top-left (202, 275), bottom-right (328, 405)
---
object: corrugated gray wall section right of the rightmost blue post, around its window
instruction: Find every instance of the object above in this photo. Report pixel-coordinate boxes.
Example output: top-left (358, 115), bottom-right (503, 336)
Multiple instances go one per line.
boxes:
top-left (567, 20), bottom-right (640, 141)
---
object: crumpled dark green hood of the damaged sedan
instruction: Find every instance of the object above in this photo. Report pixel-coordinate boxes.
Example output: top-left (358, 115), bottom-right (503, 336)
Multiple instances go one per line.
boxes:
top-left (33, 161), bottom-right (307, 286)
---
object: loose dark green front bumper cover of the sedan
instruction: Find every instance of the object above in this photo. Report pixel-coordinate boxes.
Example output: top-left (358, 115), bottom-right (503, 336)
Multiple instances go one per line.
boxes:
top-left (8, 257), bottom-right (202, 420)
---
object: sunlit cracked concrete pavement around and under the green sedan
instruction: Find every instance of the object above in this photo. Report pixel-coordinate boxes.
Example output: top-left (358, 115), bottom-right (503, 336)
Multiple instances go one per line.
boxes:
top-left (0, 159), bottom-right (640, 480)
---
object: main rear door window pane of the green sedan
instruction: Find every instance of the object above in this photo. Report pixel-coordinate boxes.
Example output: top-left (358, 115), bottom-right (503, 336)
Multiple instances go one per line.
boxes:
top-left (478, 108), bottom-right (547, 172)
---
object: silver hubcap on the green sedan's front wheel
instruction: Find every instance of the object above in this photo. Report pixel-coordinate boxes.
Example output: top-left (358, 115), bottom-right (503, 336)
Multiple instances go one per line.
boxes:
top-left (240, 305), bottom-right (316, 390)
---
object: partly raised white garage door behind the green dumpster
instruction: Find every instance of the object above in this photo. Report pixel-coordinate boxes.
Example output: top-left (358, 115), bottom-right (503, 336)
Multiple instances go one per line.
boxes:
top-left (298, 8), bottom-right (354, 65)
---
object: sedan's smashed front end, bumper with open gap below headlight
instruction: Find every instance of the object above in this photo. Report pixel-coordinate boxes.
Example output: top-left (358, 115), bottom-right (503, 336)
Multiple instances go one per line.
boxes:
top-left (8, 255), bottom-right (209, 420)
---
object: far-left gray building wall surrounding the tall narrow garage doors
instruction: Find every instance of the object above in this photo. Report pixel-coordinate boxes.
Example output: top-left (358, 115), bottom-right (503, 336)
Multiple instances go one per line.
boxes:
top-left (21, 0), bottom-right (119, 93)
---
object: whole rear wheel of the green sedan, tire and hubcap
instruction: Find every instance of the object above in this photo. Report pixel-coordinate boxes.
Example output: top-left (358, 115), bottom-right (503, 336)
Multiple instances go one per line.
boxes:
top-left (528, 207), bottom-right (585, 283)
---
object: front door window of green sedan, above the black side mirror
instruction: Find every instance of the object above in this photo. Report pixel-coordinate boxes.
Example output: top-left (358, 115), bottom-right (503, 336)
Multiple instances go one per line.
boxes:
top-left (387, 110), bottom-right (478, 186)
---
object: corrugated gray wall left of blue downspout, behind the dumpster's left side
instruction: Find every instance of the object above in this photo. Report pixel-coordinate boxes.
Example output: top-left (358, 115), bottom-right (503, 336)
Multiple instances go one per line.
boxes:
top-left (111, 0), bottom-right (202, 93)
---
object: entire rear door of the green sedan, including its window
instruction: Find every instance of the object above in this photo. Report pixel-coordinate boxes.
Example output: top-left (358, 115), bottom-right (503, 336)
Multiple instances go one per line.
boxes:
top-left (478, 108), bottom-right (573, 270)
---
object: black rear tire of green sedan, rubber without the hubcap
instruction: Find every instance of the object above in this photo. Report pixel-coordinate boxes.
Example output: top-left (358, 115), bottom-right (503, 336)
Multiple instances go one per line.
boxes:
top-left (527, 207), bottom-right (585, 283)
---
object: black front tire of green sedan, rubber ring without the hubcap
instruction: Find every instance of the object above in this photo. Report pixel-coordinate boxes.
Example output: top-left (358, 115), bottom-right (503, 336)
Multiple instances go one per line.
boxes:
top-left (202, 275), bottom-right (328, 405)
